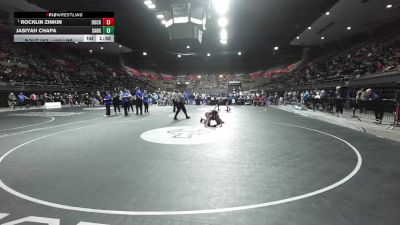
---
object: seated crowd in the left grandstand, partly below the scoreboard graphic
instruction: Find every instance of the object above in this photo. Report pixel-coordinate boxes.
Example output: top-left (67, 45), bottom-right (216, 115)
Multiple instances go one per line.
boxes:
top-left (0, 33), bottom-right (154, 91)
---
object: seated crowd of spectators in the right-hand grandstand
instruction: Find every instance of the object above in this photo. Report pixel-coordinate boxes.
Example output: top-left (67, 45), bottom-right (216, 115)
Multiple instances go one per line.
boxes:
top-left (261, 33), bottom-right (400, 90)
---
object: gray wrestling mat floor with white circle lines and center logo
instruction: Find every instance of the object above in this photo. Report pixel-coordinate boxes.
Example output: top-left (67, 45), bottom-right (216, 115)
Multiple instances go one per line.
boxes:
top-left (0, 106), bottom-right (400, 225)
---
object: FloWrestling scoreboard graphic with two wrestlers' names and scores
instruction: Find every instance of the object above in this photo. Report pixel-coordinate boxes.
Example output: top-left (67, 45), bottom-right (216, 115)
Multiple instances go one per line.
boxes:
top-left (14, 12), bottom-right (115, 42)
